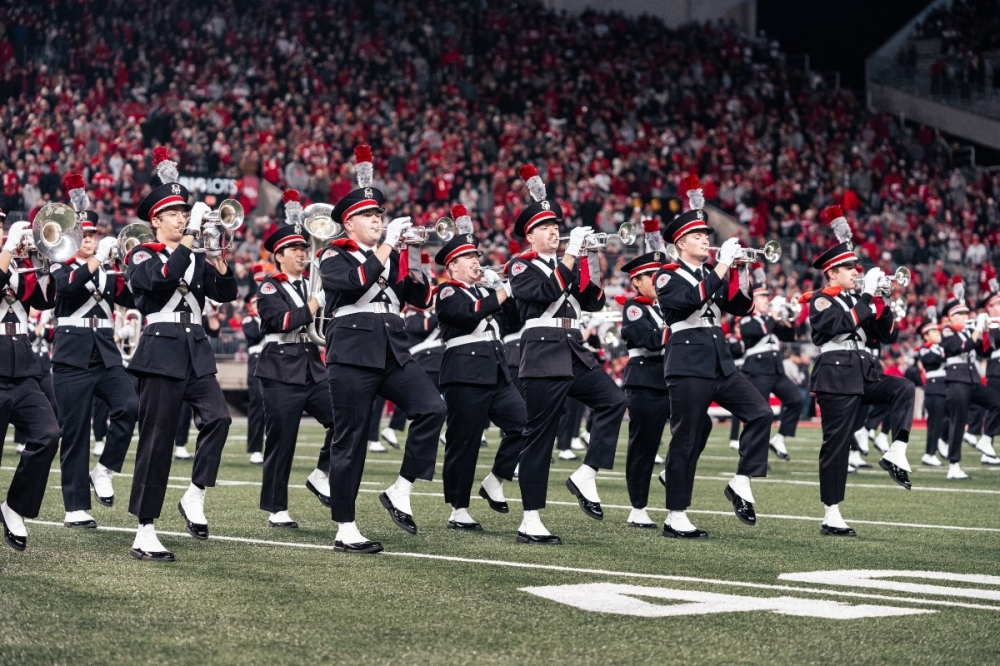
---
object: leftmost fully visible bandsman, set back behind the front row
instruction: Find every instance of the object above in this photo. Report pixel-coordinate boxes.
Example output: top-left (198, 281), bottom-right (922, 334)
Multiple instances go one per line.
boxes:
top-left (52, 174), bottom-right (139, 527)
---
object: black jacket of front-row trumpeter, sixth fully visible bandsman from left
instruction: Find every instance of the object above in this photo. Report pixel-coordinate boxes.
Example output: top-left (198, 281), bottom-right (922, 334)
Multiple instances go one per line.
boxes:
top-left (510, 252), bottom-right (606, 379)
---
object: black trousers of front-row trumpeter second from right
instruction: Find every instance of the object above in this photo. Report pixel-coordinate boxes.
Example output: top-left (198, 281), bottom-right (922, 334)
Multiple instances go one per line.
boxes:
top-left (666, 372), bottom-right (774, 511)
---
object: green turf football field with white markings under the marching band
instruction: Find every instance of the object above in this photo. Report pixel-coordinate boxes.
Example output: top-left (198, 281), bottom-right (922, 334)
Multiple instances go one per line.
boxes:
top-left (0, 420), bottom-right (1000, 665)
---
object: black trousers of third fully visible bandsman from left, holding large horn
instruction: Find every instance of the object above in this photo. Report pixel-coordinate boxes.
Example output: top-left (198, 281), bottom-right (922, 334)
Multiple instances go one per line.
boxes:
top-left (260, 379), bottom-right (333, 513)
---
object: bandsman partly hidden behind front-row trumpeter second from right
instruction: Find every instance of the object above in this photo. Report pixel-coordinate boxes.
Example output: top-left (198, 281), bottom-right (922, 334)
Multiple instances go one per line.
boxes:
top-left (621, 220), bottom-right (676, 529)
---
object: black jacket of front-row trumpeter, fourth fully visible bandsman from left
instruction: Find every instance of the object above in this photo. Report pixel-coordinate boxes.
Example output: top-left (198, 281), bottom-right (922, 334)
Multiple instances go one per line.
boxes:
top-left (319, 238), bottom-right (434, 370)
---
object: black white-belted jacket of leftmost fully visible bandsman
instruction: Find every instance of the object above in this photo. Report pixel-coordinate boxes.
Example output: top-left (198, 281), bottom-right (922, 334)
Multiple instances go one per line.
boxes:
top-left (52, 258), bottom-right (135, 368)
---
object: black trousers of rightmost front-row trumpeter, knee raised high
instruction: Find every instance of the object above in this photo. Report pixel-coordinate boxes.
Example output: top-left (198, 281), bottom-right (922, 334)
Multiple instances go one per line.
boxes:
top-left (816, 375), bottom-right (914, 506)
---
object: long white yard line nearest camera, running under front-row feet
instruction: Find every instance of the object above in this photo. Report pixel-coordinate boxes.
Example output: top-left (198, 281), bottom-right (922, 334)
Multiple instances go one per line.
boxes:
top-left (19, 520), bottom-right (1000, 612)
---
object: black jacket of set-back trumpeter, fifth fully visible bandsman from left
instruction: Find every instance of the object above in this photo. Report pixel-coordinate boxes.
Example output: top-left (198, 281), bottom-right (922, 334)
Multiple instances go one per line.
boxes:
top-left (436, 280), bottom-right (517, 386)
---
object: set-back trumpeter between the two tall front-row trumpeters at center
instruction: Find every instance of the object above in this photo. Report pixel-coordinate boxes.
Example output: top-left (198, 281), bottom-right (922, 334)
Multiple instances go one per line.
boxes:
top-left (435, 205), bottom-right (525, 530)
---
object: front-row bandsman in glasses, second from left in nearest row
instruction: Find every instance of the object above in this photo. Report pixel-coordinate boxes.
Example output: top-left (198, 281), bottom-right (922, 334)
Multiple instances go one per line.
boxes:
top-left (128, 146), bottom-right (237, 562)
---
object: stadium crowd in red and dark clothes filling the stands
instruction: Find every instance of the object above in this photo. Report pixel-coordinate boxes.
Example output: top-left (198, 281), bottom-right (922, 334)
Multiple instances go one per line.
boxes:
top-left (0, 0), bottom-right (1000, 368)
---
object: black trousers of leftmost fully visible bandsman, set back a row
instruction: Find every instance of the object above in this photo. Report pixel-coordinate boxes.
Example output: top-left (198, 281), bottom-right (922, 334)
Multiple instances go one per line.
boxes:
top-left (52, 359), bottom-right (139, 511)
